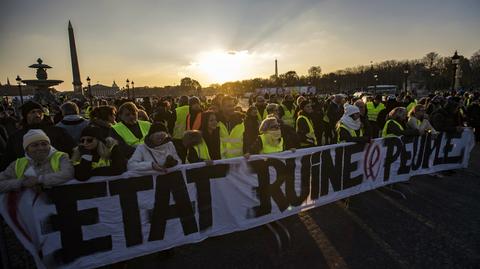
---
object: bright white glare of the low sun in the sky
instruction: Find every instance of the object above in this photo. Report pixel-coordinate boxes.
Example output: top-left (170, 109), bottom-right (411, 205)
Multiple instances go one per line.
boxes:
top-left (195, 50), bottom-right (252, 83)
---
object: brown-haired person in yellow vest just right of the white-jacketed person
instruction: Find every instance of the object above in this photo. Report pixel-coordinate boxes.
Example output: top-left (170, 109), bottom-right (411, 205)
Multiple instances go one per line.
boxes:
top-left (183, 130), bottom-right (212, 163)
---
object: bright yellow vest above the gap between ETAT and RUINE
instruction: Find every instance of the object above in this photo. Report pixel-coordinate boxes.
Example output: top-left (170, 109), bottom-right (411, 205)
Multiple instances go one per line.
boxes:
top-left (218, 122), bottom-right (245, 159)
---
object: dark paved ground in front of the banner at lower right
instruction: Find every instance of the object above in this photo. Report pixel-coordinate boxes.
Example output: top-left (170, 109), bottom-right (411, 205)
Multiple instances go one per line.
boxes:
top-left (129, 145), bottom-right (480, 268)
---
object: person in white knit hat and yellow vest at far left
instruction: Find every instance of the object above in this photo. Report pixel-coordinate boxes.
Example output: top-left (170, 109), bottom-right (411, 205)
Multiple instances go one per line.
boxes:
top-left (0, 129), bottom-right (73, 193)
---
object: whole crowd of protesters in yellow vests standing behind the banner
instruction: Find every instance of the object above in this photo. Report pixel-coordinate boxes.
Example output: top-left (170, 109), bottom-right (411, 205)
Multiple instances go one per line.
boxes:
top-left (0, 91), bottom-right (480, 192)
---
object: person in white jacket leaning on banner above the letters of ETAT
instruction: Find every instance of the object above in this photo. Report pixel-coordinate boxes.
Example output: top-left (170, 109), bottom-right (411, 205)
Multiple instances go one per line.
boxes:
top-left (127, 124), bottom-right (182, 172)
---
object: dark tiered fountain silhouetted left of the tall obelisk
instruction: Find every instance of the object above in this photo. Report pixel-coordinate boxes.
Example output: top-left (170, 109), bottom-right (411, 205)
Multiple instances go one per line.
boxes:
top-left (22, 58), bottom-right (63, 105)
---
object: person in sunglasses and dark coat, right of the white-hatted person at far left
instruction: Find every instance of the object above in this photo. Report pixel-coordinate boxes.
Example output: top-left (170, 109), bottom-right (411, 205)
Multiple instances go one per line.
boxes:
top-left (72, 126), bottom-right (128, 181)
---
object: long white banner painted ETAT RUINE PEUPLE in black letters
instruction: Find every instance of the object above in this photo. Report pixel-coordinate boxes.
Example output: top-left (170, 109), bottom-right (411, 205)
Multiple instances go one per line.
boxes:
top-left (0, 129), bottom-right (474, 268)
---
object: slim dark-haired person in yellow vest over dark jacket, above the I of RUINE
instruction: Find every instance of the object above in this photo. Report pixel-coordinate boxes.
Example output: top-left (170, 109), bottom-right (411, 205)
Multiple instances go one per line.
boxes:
top-left (295, 100), bottom-right (318, 148)
